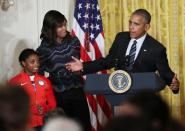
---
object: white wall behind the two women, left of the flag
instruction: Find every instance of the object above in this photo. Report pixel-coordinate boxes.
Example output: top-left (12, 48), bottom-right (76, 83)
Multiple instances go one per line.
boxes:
top-left (0, 0), bottom-right (75, 82)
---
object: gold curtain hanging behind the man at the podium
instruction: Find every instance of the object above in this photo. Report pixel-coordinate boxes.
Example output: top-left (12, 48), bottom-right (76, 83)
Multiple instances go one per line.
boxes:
top-left (99, 0), bottom-right (185, 124)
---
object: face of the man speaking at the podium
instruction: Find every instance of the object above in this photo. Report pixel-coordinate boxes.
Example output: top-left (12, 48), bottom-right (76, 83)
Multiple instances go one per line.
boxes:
top-left (129, 14), bottom-right (150, 39)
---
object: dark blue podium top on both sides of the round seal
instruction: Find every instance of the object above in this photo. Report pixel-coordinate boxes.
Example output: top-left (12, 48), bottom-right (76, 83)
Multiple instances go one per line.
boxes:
top-left (84, 72), bottom-right (166, 94)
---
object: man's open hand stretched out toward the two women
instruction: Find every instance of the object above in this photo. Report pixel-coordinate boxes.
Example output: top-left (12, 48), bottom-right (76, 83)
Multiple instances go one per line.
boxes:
top-left (65, 56), bottom-right (83, 72)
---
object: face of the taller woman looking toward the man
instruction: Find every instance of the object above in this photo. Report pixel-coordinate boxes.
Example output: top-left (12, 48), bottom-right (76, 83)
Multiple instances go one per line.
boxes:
top-left (56, 21), bottom-right (67, 39)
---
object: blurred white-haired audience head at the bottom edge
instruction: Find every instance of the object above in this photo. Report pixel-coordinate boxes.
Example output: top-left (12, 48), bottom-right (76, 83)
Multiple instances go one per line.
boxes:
top-left (43, 117), bottom-right (82, 131)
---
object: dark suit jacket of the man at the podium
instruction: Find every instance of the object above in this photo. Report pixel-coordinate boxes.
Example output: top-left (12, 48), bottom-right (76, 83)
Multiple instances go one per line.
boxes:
top-left (83, 32), bottom-right (174, 85)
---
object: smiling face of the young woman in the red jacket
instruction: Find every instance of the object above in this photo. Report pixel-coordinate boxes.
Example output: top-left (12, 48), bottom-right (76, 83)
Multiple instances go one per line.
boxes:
top-left (22, 54), bottom-right (40, 75)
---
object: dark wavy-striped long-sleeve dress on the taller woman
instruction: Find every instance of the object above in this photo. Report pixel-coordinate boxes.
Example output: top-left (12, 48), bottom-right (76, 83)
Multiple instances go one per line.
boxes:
top-left (37, 34), bottom-right (91, 131)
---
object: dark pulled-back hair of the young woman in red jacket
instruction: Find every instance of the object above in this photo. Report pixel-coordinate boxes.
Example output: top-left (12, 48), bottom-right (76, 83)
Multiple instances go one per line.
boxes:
top-left (19, 48), bottom-right (38, 66)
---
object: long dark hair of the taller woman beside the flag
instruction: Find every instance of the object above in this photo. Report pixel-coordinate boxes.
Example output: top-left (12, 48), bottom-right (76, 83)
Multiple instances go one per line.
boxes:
top-left (40, 10), bottom-right (67, 44)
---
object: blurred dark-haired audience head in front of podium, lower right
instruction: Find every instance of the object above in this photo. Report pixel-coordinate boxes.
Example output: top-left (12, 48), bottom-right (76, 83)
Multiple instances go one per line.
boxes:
top-left (119, 91), bottom-right (170, 129)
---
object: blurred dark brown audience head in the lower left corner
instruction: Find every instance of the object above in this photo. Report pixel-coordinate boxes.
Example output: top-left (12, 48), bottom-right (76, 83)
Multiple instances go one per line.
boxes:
top-left (0, 85), bottom-right (30, 131)
